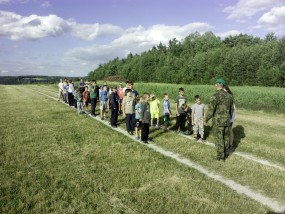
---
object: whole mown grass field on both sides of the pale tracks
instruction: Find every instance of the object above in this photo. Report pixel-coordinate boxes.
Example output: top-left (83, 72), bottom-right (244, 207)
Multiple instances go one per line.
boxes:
top-left (0, 86), bottom-right (285, 213)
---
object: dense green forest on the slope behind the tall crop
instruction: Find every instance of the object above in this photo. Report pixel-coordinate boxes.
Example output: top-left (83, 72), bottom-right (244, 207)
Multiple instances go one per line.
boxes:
top-left (88, 32), bottom-right (285, 87)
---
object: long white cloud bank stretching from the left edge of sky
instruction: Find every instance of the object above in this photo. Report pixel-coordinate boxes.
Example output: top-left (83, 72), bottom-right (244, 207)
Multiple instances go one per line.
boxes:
top-left (0, 11), bottom-right (122, 40)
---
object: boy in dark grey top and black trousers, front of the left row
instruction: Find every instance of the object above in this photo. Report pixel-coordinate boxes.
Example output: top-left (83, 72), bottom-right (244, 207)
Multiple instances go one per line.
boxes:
top-left (140, 93), bottom-right (150, 144)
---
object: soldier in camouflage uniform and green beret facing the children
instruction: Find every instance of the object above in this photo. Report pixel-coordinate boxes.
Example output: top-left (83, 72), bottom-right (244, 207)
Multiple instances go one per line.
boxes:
top-left (206, 79), bottom-right (234, 161)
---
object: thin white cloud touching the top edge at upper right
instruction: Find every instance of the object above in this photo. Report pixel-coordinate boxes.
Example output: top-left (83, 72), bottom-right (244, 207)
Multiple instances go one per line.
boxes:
top-left (224, 0), bottom-right (285, 22)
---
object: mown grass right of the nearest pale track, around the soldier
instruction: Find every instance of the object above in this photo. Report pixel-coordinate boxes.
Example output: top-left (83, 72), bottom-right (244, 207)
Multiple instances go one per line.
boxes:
top-left (38, 84), bottom-right (285, 202)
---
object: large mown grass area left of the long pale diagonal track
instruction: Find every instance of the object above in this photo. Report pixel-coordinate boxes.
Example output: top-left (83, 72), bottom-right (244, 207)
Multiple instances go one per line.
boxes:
top-left (0, 86), bottom-right (268, 213)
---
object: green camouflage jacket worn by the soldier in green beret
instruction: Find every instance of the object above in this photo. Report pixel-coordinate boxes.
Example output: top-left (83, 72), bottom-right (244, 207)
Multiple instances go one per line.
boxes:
top-left (206, 89), bottom-right (234, 126)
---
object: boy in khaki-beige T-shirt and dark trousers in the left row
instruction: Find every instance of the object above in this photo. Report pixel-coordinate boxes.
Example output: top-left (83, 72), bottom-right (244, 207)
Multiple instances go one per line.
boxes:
top-left (123, 89), bottom-right (135, 135)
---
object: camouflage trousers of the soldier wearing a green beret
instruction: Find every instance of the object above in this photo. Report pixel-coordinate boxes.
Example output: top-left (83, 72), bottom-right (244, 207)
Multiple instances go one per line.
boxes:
top-left (213, 126), bottom-right (230, 158)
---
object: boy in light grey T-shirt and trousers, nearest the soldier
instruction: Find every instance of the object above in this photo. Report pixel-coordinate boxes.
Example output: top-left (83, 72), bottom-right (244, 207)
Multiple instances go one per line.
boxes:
top-left (192, 95), bottom-right (205, 142)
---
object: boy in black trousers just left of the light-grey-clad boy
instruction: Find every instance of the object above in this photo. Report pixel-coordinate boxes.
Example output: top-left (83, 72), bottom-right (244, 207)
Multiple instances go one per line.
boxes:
top-left (173, 88), bottom-right (187, 133)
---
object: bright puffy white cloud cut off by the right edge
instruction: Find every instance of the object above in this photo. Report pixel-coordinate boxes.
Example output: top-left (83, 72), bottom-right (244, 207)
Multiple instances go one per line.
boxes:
top-left (255, 5), bottom-right (285, 33)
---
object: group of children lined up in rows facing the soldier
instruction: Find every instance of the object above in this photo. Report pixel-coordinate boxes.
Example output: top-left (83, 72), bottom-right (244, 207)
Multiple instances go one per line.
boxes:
top-left (58, 80), bottom-right (205, 143)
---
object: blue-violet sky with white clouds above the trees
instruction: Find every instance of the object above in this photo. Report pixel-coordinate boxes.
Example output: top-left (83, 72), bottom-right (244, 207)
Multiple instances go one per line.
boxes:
top-left (0, 0), bottom-right (285, 77)
